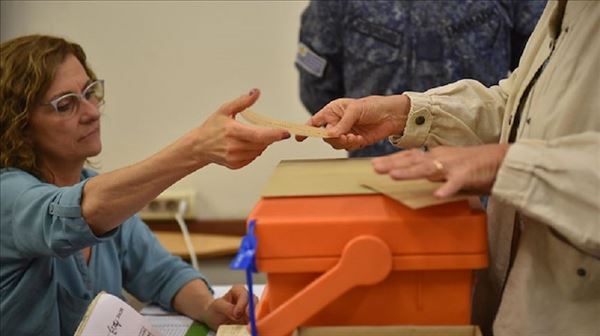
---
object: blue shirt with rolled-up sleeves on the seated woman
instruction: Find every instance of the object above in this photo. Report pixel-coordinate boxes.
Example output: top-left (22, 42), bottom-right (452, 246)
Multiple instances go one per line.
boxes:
top-left (0, 169), bottom-right (203, 336)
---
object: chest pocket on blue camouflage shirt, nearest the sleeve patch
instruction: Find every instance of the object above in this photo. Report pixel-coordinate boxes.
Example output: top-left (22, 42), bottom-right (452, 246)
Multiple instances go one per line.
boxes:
top-left (344, 18), bottom-right (404, 65)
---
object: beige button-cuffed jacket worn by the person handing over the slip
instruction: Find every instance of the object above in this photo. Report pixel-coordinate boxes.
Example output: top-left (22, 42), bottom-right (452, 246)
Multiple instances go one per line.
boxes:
top-left (390, 1), bottom-right (600, 336)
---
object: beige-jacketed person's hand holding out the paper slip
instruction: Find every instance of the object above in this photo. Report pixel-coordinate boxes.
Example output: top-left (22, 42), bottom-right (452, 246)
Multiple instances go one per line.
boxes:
top-left (296, 95), bottom-right (410, 150)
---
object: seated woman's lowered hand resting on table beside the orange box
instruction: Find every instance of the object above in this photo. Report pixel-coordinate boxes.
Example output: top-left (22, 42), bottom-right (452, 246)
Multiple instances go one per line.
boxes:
top-left (203, 285), bottom-right (258, 330)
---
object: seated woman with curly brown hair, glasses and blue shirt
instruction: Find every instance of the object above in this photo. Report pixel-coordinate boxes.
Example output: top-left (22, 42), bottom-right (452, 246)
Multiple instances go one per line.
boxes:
top-left (0, 35), bottom-right (290, 336)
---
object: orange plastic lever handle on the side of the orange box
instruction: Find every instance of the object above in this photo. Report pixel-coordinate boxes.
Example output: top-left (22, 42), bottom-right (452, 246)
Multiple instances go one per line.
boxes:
top-left (257, 235), bottom-right (392, 336)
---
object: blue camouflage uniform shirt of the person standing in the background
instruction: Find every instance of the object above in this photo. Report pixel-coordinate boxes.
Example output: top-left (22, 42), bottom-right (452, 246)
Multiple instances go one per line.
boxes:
top-left (296, 0), bottom-right (545, 156)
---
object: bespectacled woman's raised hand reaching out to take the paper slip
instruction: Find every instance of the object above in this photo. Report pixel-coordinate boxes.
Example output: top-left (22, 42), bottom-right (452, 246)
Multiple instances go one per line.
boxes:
top-left (194, 89), bottom-right (290, 169)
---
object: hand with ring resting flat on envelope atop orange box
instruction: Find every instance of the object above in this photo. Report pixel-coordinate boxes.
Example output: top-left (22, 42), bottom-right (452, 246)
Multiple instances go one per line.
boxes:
top-left (372, 144), bottom-right (509, 197)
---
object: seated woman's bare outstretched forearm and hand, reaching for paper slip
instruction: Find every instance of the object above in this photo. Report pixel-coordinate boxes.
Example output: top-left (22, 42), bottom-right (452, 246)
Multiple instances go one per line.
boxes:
top-left (81, 90), bottom-right (290, 235)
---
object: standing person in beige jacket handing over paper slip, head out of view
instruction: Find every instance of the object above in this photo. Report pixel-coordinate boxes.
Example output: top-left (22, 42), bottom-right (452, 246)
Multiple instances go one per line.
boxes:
top-left (297, 0), bottom-right (600, 336)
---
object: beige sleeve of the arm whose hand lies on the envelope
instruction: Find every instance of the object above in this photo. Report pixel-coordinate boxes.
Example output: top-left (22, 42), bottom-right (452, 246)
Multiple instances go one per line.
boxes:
top-left (492, 132), bottom-right (600, 258)
